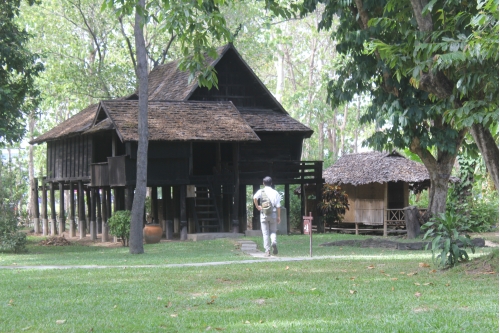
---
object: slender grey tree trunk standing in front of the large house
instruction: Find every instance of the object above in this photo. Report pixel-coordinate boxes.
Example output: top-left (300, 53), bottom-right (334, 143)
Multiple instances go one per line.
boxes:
top-left (129, 0), bottom-right (149, 254)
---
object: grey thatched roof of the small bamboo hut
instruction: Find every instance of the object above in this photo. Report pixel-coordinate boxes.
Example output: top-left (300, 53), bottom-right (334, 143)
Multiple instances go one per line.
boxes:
top-left (323, 152), bottom-right (429, 185)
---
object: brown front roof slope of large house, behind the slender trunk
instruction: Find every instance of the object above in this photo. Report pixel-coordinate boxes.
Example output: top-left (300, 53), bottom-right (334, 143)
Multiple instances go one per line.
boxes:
top-left (96, 100), bottom-right (260, 142)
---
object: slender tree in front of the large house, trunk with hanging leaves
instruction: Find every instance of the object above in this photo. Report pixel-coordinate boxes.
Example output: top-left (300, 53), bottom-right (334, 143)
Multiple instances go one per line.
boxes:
top-left (103, 0), bottom-right (231, 254)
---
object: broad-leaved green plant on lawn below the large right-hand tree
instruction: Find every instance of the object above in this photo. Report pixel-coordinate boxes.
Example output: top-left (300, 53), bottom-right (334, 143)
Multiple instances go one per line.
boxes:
top-left (422, 212), bottom-right (475, 268)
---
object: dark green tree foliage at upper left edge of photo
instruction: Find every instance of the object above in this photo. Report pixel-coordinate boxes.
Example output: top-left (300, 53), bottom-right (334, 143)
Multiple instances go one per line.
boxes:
top-left (0, 0), bottom-right (43, 144)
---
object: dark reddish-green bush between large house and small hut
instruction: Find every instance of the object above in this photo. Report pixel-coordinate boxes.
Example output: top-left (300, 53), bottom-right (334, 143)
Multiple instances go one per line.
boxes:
top-left (318, 184), bottom-right (349, 225)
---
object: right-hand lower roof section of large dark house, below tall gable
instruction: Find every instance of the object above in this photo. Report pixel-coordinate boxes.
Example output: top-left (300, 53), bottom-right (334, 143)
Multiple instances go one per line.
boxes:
top-left (238, 107), bottom-right (313, 137)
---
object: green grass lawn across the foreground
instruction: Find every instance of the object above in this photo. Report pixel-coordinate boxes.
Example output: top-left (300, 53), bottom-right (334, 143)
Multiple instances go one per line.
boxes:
top-left (0, 235), bottom-right (499, 332)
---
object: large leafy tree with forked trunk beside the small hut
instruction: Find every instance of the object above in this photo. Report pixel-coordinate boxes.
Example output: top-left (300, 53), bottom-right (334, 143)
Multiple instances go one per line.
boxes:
top-left (304, 0), bottom-right (496, 215)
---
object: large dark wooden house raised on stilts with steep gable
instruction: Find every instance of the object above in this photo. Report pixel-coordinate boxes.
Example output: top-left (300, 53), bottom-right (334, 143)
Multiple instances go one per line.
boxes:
top-left (31, 45), bottom-right (322, 239)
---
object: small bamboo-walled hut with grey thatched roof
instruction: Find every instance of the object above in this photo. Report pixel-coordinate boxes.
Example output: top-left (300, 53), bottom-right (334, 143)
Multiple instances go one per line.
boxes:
top-left (323, 151), bottom-right (430, 235)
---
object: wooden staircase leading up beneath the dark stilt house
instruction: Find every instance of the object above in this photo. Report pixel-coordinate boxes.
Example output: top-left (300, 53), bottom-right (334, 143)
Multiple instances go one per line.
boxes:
top-left (193, 186), bottom-right (223, 233)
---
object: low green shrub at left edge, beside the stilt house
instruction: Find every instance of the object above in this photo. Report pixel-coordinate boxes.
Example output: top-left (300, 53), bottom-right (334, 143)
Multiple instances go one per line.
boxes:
top-left (0, 210), bottom-right (26, 253)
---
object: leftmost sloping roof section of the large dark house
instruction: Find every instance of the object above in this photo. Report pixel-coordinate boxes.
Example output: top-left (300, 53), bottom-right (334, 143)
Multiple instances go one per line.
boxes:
top-left (30, 104), bottom-right (99, 144)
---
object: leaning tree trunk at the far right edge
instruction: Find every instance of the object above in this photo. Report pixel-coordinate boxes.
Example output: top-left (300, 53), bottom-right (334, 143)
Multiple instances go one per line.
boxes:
top-left (470, 124), bottom-right (498, 191)
